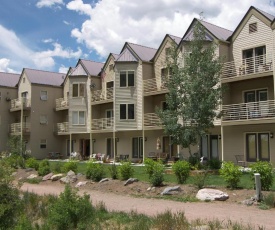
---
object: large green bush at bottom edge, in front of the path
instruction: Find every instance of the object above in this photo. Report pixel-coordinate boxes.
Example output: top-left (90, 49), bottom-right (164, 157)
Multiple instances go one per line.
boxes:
top-left (46, 185), bottom-right (94, 230)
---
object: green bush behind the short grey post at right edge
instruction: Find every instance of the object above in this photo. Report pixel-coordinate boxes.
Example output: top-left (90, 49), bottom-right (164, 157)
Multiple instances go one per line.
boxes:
top-left (250, 161), bottom-right (273, 191)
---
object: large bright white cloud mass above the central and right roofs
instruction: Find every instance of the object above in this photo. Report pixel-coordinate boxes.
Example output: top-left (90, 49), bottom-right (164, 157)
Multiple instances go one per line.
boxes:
top-left (66, 0), bottom-right (275, 57)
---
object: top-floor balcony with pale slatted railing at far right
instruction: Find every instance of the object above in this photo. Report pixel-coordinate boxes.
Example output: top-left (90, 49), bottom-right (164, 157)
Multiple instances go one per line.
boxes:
top-left (222, 55), bottom-right (273, 83)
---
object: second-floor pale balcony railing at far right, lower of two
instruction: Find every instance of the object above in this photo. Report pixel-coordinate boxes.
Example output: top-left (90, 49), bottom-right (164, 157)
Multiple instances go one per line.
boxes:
top-left (222, 100), bottom-right (275, 121)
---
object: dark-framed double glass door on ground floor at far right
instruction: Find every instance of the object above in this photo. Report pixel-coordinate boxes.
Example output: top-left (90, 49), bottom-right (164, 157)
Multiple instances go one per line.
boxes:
top-left (246, 133), bottom-right (270, 161)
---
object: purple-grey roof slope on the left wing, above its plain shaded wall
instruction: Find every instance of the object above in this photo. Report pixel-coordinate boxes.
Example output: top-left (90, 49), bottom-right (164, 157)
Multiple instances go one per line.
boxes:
top-left (22, 68), bottom-right (66, 86)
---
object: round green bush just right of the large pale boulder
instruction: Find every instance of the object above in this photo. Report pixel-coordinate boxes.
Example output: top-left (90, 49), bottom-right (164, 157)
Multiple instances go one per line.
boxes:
top-left (219, 161), bottom-right (242, 189)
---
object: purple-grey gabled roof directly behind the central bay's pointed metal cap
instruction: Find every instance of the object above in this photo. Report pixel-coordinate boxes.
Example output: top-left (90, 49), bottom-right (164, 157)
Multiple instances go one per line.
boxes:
top-left (120, 42), bottom-right (157, 62)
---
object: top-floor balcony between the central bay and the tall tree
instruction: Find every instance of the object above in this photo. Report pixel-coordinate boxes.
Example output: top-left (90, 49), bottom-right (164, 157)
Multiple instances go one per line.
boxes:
top-left (143, 76), bottom-right (169, 96)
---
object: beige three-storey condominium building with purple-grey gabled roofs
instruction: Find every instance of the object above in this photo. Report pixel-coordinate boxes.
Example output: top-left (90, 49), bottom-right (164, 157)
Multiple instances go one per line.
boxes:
top-left (0, 7), bottom-right (275, 162)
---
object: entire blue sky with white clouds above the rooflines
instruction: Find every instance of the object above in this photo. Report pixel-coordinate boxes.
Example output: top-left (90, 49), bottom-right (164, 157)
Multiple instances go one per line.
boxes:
top-left (0, 0), bottom-right (275, 73)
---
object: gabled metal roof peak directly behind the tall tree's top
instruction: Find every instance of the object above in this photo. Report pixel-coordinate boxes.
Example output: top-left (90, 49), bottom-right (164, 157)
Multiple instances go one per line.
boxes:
top-left (182, 18), bottom-right (233, 41)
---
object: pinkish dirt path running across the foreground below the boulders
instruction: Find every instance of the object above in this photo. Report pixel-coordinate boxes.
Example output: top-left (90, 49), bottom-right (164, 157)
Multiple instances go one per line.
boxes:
top-left (21, 183), bottom-right (275, 230)
